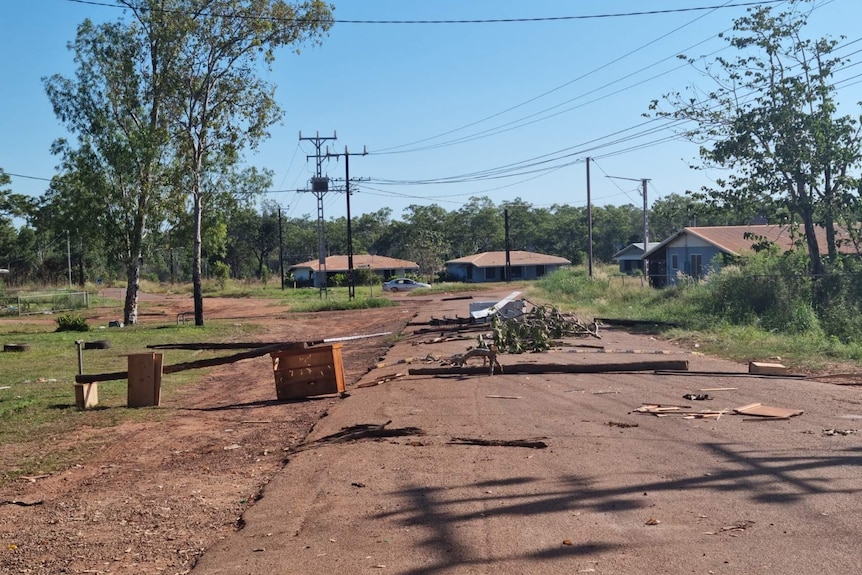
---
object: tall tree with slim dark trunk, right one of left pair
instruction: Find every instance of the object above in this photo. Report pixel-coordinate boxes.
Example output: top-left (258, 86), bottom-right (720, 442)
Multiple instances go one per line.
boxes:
top-left (164, 0), bottom-right (332, 325)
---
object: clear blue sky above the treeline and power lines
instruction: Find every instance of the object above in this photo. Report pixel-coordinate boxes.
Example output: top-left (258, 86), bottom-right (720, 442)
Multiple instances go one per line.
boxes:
top-left (0, 0), bottom-right (862, 227)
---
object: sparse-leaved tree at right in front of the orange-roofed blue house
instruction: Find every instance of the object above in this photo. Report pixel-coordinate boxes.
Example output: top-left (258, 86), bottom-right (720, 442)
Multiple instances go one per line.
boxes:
top-left (651, 0), bottom-right (862, 275)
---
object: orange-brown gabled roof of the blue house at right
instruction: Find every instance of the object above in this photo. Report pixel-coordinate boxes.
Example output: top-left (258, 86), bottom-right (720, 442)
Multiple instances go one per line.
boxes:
top-left (644, 225), bottom-right (856, 259)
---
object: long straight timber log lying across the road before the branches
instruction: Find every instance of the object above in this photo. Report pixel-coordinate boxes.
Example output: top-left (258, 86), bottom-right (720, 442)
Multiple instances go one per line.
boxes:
top-left (408, 360), bottom-right (688, 375)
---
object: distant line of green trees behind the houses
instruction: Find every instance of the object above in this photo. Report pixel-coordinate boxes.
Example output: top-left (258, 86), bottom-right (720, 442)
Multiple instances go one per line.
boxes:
top-left (0, 180), bottom-right (747, 285)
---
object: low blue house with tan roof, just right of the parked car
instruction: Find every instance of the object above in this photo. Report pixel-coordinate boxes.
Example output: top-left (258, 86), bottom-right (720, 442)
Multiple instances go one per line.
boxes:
top-left (445, 251), bottom-right (572, 283)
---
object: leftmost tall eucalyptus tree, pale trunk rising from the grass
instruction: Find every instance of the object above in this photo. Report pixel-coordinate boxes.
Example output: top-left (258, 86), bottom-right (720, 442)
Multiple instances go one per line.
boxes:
top-left (44, 13), bottom-right (177, 324)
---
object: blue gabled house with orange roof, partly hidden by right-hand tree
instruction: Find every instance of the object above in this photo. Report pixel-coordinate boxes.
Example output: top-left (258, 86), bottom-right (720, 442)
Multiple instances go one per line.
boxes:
top-left (643, 225), bottom-right (856, 287)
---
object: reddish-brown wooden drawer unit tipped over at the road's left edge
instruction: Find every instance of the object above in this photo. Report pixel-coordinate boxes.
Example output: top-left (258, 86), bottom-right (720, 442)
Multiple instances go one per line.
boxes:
top-left (270, 343), bottom-right (344, 400)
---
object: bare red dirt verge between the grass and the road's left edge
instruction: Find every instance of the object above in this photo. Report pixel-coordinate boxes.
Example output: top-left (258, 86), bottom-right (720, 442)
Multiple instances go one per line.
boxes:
top-left (0, 297), bottom-right (426, 574)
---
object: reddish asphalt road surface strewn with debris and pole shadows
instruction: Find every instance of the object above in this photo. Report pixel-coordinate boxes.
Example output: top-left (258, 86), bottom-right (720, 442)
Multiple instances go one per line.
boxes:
top-left (192, 294), bottom-right (862, 575)
